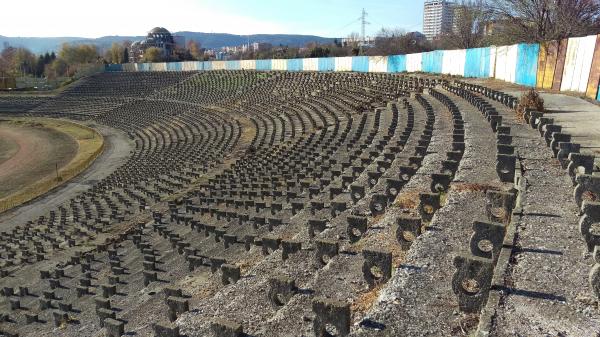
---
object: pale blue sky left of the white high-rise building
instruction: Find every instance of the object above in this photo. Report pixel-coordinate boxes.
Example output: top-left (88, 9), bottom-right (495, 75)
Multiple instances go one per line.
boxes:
top-left (0, 0), bottom-right (424, 37)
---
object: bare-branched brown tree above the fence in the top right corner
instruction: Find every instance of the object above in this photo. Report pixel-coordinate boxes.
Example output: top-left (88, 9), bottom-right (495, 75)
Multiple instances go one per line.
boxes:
top-left (488, 0), bottom-right (600, 42)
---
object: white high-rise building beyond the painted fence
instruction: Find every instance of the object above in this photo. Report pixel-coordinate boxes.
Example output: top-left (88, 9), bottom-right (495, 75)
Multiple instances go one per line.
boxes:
top-left (423, 0), bottom-right (454, 40)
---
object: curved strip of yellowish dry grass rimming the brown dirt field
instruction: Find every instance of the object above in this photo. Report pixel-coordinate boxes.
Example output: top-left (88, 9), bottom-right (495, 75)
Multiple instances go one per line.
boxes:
top-left (0, 118), bottom-right (104, 213)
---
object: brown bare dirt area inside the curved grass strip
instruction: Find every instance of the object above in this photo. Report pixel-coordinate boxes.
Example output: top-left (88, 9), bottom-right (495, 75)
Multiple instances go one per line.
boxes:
top-left (0, 122), bottom-right (79, 198)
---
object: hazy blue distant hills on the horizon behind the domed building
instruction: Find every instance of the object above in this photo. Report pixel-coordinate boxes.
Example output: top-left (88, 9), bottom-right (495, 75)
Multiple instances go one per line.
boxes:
top-left (0, 32), bottom-right (333, 54)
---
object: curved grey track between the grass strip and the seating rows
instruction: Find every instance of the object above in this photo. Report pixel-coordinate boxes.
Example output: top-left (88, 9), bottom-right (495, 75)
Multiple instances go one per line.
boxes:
top-left (0, 124), bottom-right (135, 231)
